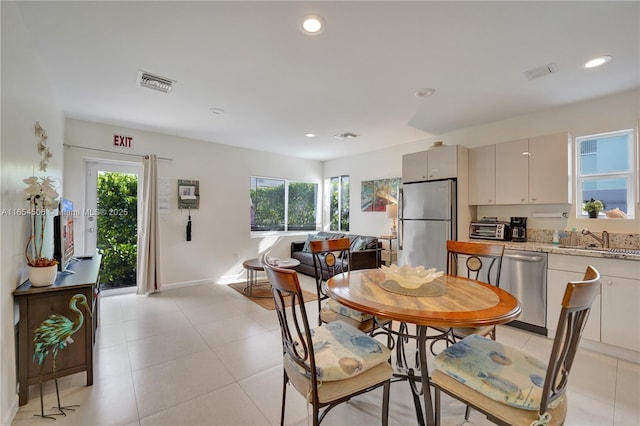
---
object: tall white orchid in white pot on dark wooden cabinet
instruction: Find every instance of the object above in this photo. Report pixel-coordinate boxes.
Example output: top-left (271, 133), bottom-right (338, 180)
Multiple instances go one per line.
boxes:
top-left (23, 176), bottom-right (59, 287)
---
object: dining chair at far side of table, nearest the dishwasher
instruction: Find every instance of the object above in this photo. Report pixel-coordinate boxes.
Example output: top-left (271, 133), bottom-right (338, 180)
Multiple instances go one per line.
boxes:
top-left (431, 240), bottom-right (504, 355)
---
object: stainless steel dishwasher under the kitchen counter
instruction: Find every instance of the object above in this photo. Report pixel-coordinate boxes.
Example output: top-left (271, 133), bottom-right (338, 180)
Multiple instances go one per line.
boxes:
top-left (500, 249), bottom-right (547, 336)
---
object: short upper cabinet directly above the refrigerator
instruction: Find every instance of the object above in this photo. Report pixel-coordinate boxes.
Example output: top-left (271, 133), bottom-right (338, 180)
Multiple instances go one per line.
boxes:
top-left (402, 145), bottom-right (463, 183)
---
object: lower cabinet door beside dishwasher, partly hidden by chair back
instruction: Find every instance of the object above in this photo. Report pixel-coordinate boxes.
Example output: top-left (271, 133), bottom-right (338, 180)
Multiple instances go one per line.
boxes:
top-left (547, 269), bottom-right (600, 342)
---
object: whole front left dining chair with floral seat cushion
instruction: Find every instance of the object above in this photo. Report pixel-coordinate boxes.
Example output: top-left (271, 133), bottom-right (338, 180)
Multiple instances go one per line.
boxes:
top-left (262, 255), bottom-right (393, 426)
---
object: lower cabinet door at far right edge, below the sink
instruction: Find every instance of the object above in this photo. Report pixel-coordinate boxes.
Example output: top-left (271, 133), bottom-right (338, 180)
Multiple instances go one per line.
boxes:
top-left (604, 275), bottom-right (640, 351)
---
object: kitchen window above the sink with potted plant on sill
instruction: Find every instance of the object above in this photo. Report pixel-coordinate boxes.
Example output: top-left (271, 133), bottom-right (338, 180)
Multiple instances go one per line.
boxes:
top-left (576, 130), bottom-right (637, 218)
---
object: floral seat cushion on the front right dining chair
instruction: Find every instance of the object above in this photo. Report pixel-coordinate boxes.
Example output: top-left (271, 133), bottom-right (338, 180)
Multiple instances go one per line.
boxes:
top-left (435, 335), bottom-right (562, 410)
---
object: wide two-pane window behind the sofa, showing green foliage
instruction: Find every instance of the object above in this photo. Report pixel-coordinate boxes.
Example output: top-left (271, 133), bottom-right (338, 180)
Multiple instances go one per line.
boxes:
top-left (250, 176), bottom-right (318, 231)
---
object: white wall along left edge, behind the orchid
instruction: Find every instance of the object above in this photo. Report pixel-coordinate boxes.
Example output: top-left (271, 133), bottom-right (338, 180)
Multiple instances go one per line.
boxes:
top-left (0, 2), bottom-right (64, 424)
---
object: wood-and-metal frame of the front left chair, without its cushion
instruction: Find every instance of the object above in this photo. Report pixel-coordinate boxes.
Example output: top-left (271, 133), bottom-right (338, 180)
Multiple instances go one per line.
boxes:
top-left (262, 255), bottom-right (391, 426)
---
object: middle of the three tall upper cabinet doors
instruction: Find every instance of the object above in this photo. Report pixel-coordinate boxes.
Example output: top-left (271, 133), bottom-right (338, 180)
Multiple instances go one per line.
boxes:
top-left (496, 139), bottom-right (529, 204)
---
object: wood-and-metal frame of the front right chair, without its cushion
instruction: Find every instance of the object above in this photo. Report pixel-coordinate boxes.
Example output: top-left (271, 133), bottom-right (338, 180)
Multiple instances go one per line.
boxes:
top-left (434, 266), bottom-right (600, 425)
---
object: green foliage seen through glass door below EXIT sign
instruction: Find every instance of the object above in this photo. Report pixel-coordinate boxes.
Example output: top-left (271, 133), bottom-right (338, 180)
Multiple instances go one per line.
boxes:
top-left (97, 172), bottom-right (138, 287)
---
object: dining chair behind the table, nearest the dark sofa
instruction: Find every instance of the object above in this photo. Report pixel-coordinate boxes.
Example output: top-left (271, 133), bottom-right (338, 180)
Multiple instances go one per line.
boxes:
top-left (309, 238), bottom-right (375, 333)
